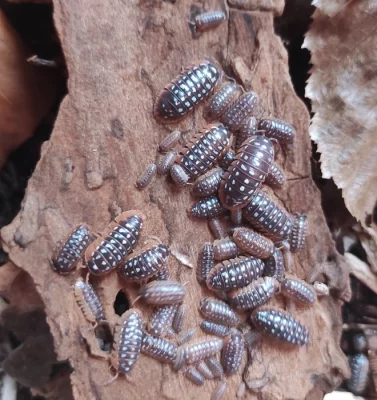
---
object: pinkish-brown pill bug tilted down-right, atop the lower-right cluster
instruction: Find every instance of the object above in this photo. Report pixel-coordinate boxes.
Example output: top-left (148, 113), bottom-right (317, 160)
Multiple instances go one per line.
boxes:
top-left (233, 228), bottom-right (275, 259)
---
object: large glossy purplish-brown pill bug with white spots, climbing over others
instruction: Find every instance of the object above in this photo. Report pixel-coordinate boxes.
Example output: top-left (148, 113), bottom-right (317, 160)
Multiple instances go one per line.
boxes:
top-left (219, 136), bottom-right (275, 210)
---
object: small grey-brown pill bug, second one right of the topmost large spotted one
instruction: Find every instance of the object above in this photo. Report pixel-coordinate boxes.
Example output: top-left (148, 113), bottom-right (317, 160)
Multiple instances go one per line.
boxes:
top-left (220, 92), bottom-right (258, 132)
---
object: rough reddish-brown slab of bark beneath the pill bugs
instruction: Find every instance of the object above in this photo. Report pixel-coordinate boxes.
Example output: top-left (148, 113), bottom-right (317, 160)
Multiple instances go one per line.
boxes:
top-left (2, 0), bottom-right (348, 400)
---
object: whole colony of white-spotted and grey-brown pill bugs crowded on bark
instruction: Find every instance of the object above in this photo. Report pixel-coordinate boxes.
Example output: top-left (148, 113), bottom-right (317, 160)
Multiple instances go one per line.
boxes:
top-left (51, 12), bottom-right (328, 399)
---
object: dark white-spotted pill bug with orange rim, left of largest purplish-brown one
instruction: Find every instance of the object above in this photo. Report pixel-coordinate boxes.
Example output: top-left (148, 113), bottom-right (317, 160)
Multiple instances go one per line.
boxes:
top-left (176, 123), bottom-right (230, 181)
